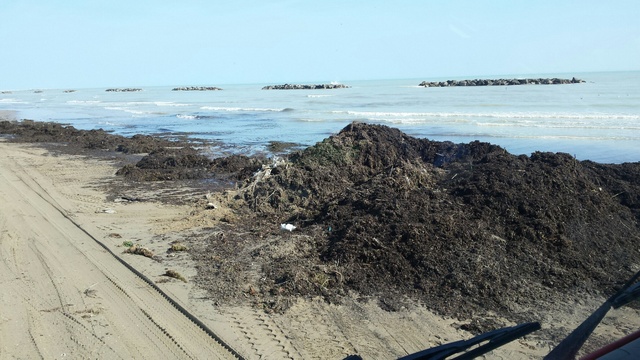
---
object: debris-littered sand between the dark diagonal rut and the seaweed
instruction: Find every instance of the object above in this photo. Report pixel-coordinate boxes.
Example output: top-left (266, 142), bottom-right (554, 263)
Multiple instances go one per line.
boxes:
top-left (0, 119), bottom-right (639, 358)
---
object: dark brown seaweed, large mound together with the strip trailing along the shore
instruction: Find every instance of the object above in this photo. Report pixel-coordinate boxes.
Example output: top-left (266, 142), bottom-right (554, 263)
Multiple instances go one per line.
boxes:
top-left (0, 122), bottom-right (640, 321)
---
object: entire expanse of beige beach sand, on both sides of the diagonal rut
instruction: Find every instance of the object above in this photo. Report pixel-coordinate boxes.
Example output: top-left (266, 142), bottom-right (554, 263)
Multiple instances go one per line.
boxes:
top-left (0, 141), bottom-right (640, 359)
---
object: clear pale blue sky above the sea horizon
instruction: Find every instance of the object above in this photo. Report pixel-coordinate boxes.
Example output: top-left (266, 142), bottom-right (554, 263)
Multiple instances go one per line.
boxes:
top-left (0, 0), bottom-right (640, 90)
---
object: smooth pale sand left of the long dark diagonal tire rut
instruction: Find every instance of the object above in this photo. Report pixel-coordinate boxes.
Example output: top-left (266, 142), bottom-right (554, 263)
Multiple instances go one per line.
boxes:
top-left (0, 143), bottom-right (239, 359)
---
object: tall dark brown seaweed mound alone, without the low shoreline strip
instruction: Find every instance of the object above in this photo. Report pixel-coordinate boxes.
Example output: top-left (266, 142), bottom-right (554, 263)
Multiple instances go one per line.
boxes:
top-left (231, 123), bottom-right (640, 318)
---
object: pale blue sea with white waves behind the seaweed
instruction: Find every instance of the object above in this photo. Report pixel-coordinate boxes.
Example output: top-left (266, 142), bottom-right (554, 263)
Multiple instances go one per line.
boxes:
top-left (0, 71), bottom-right (640, 163)
